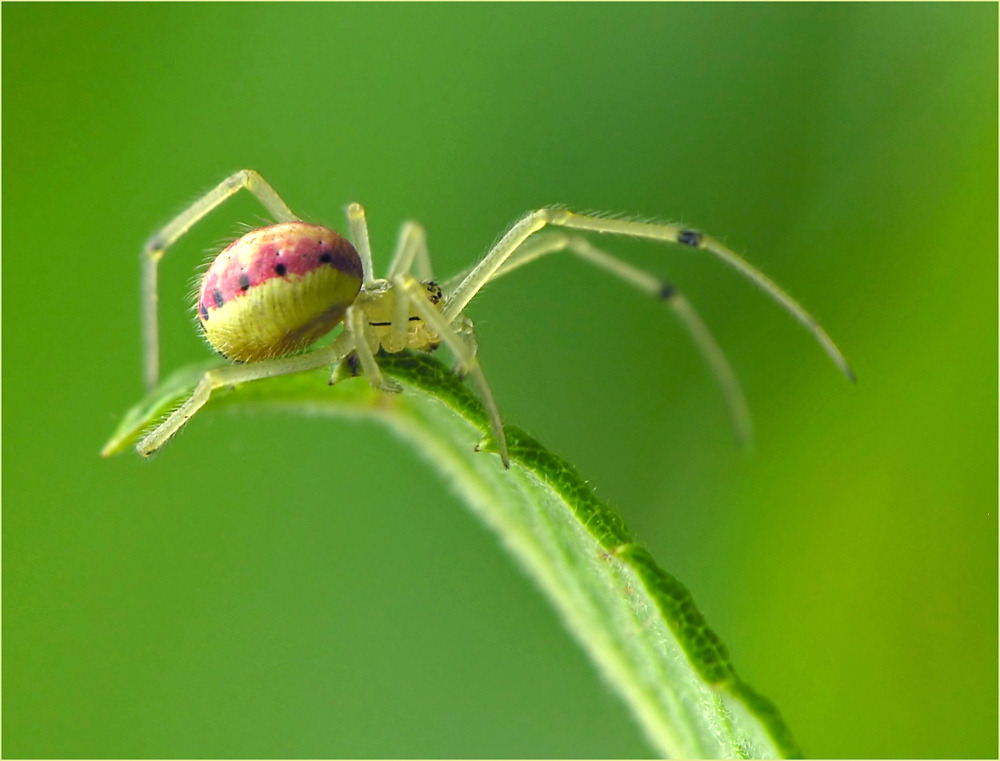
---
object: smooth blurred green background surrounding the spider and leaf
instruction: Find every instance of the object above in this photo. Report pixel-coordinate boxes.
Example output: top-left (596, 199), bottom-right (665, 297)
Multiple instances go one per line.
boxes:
top-left (2, 3), bottom-right (998, 757)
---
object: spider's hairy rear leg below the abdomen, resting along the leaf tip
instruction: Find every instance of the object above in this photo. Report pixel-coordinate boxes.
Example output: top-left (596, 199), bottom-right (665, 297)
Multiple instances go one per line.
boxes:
top-left (136, 331), bottom-right (354, 457)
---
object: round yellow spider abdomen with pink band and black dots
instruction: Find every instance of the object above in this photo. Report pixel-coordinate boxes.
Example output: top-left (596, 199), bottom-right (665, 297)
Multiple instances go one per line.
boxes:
top-left (198, 222), bottom-right (363, 362)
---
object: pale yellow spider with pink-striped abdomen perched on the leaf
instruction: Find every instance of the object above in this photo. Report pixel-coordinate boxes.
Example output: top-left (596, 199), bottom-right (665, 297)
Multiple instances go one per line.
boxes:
top-left (136, 169), bottom-right (854, 468)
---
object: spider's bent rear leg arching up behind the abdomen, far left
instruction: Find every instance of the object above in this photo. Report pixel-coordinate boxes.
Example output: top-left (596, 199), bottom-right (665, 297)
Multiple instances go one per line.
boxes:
top-left (142, 169), bottom-right (298, 390)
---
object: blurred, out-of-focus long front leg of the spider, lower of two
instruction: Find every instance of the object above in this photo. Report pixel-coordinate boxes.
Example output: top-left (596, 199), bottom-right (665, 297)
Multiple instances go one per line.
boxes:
top-left (493, 232), bottom-right (753, 446)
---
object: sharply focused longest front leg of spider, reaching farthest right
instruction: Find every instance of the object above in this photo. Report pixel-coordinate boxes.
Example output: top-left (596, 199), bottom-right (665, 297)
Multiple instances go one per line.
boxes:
top-left (442, 209), bottom-right (855, 381)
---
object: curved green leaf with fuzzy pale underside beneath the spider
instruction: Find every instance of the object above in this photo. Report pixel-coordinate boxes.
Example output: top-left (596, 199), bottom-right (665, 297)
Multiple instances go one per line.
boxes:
top-left (104, 353), bottom-right (800, 758)
